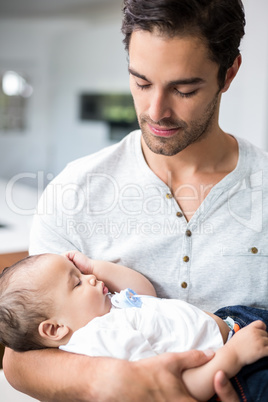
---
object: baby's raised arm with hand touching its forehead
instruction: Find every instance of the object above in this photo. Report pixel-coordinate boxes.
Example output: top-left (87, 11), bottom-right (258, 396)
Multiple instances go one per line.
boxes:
top-left (65, 250), bottom-right (156, 296)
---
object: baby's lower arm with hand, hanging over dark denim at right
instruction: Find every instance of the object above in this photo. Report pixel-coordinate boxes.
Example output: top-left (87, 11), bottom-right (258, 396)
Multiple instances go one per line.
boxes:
top-left (182, 321), bottom-right (268, 401)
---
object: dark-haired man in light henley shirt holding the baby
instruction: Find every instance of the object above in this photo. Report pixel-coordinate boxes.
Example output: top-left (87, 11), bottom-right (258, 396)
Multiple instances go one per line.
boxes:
top-left (4, 0), bottom-right (268, 402)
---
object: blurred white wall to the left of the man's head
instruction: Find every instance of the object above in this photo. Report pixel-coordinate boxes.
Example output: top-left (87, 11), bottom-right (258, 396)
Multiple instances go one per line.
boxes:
top-left (0, 0), bottom-right (126, 185)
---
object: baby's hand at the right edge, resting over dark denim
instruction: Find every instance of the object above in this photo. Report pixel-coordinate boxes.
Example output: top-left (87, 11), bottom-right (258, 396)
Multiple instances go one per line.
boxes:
top-left (226, 321), bottom-right (268, 366)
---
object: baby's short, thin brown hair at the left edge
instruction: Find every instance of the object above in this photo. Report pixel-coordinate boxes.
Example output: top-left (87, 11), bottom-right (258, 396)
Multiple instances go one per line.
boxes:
top-left (0, 255), bottom-right (51, 352)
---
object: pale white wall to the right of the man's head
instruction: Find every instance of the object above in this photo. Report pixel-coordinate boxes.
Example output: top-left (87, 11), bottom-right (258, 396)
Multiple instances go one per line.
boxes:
top-left (220, 0), bottom-right (268, 150)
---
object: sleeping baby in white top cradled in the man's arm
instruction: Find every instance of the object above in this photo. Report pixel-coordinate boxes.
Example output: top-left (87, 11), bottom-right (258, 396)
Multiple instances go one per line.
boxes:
top-left (0, 251), bottom-right (268, 401)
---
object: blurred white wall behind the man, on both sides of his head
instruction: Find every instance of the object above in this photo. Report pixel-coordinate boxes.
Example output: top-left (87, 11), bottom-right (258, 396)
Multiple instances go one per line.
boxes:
top-left (0, 0), bottom-right (268, 184)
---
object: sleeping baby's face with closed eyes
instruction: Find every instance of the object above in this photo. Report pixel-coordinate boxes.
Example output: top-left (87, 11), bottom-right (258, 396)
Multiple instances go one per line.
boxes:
top-left (38, 254), bottom-right (111, 331)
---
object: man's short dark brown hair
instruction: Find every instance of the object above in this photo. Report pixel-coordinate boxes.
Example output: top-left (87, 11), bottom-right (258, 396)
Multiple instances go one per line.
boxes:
top-left (122, 0), bottom-right (245, 87)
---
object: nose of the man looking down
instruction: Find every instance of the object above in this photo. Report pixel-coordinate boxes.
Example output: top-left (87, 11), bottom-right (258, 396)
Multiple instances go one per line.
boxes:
top-left (149, 90), bottom-right (171, 122)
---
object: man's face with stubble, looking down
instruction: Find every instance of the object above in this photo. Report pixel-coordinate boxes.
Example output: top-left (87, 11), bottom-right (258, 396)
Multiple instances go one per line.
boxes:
top-left (129, 31), bottom-right (220, 156)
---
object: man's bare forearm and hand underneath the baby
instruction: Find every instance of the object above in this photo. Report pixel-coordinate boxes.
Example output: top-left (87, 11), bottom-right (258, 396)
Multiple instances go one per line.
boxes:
top-left (4, 349), bottom-right (216, 402)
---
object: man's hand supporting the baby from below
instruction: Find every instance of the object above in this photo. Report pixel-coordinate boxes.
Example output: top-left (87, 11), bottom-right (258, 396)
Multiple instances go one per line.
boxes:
top-left (91, 350), bottom-right (216, 402)
